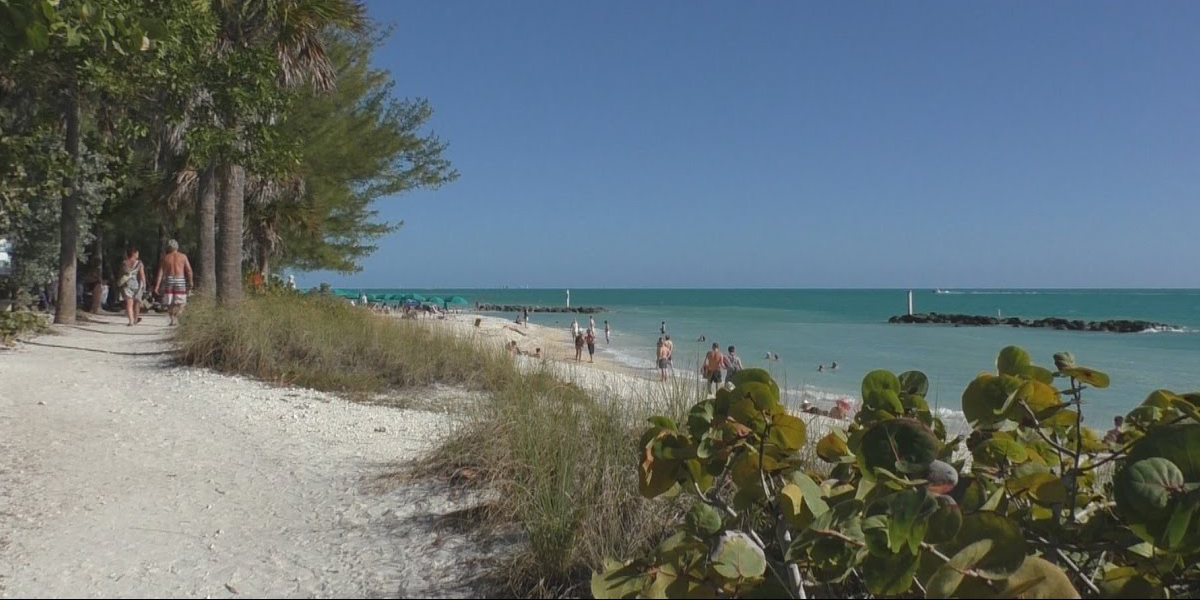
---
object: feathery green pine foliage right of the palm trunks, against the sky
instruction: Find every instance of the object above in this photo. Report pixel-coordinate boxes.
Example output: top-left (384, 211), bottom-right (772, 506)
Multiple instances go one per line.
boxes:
top-left (246, 25), bottom-right (457, 272)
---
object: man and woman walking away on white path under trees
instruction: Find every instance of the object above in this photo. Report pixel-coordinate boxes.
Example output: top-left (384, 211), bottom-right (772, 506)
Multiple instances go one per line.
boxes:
top-left (116, 240), bottom-right (193, 326)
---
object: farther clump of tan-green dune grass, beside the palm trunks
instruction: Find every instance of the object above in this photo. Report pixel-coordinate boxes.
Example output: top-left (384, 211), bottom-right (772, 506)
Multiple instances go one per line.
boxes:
top-left (175, 294), bottom-right (516, 392)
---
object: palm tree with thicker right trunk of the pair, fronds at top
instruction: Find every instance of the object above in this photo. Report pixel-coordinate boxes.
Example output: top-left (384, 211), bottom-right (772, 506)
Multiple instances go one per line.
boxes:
top-left (208, 0), bottom-right (364, 302)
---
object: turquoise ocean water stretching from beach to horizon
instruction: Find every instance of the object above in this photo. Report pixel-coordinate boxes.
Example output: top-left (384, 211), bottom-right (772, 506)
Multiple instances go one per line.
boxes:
top-left (350, 289), bottom-right (1200, 420)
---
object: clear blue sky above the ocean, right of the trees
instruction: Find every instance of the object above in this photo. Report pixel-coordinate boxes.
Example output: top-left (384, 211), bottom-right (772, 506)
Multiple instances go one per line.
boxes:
top-left (300, 0), bottom-right (1200, 288)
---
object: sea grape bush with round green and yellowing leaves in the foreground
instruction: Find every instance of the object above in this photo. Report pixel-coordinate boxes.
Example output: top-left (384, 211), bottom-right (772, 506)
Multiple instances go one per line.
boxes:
top-left (592, 347), bottom-right (1200, 598)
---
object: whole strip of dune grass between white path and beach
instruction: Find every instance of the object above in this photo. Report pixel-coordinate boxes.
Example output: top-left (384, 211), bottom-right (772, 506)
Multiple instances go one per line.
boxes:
top-left (176, 295), bottom-right (696, 598)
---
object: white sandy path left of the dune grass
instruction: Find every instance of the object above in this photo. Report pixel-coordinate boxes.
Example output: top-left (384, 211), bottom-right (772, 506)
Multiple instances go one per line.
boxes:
top-left (0, 316), bottom-right (484, 598)
